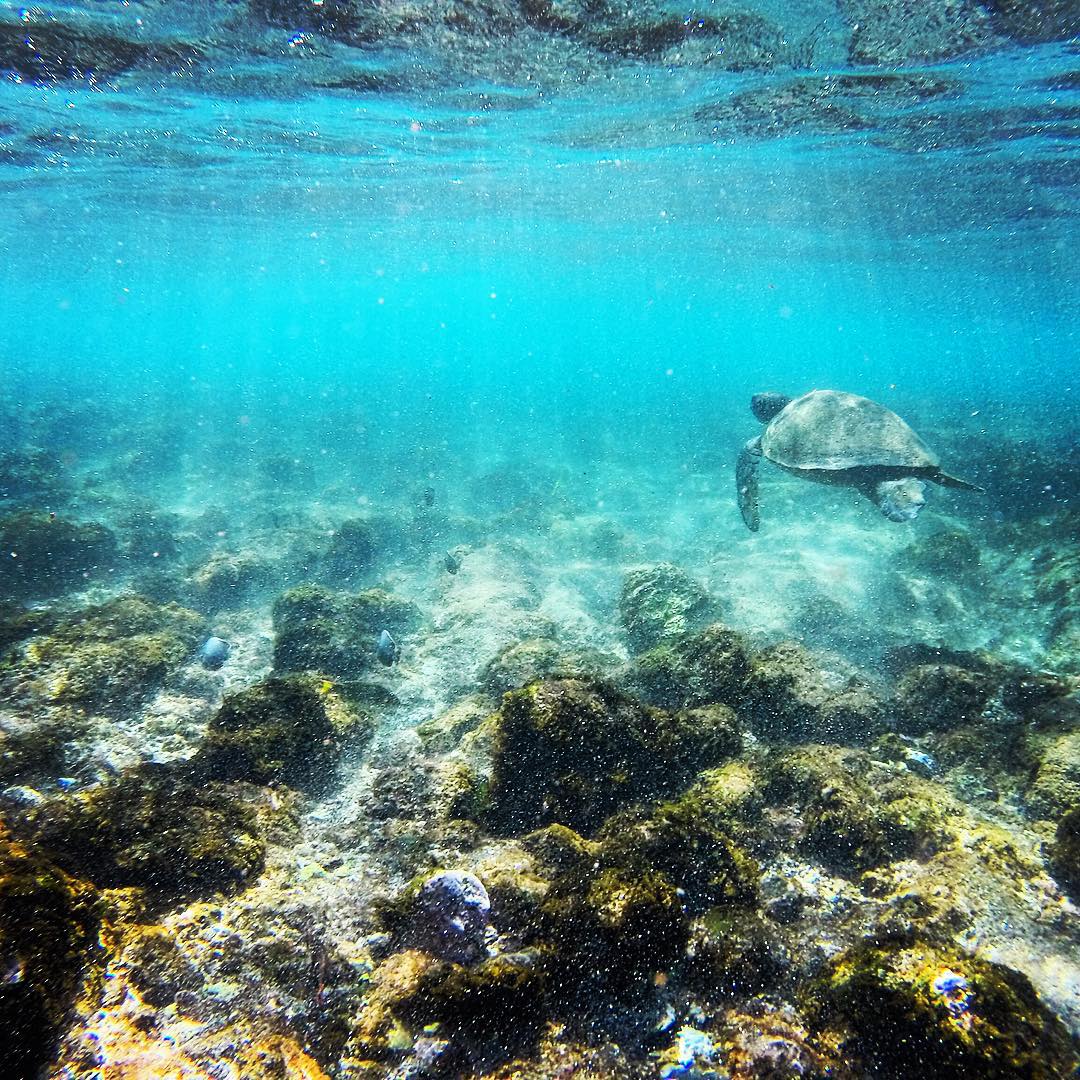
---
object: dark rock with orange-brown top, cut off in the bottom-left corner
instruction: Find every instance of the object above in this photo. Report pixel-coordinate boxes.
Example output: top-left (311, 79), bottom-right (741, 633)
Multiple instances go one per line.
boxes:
top-left (0, 825), bottom-right (100, 1080)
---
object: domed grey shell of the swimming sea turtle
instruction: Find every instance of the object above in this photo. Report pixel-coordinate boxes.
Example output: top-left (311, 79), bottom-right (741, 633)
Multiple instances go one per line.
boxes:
top-left (761, 390), bottom-right (937, 472)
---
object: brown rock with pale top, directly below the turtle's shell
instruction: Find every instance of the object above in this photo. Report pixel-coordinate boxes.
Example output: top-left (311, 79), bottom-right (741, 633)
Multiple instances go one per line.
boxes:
top-left (746, 642), bottom-right (886, 743)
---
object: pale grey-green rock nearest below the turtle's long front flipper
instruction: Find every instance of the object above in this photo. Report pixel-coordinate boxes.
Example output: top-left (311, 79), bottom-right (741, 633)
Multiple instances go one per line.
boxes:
top-left (619, 563), bottom-right (714, 652)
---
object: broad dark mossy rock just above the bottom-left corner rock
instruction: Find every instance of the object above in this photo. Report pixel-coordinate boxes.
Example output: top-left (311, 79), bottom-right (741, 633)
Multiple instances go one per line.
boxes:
top-left (29, 765), bottom-right (266, 897)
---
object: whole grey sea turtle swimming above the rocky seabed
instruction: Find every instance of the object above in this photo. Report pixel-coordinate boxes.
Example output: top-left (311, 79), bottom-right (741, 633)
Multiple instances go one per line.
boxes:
top-left (735, 390), bottom-right (983, 532)
